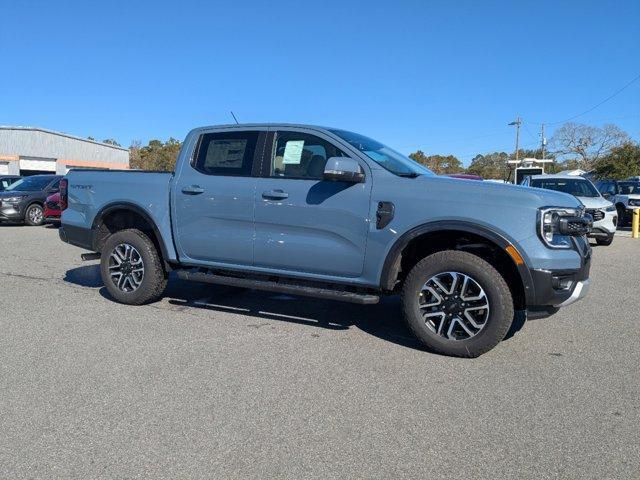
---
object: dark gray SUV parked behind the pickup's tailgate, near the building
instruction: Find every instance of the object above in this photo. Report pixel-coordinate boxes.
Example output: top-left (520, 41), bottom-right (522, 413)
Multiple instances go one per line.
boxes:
top-left (0, 175), bottom-right (62, 225)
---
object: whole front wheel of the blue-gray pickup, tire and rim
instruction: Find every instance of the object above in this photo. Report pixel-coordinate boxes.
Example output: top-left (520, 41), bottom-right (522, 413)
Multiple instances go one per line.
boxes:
top-left (402, 250), bottom-right (514, 358)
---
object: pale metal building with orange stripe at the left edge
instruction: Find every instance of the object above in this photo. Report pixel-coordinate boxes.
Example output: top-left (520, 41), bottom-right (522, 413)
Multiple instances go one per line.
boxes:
top-left (0, 126), bottom-right (129, 175)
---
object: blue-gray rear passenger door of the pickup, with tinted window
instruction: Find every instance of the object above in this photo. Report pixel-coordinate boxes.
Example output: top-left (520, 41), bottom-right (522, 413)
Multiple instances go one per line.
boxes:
top-left (171, 128), bottom-right (266, 266)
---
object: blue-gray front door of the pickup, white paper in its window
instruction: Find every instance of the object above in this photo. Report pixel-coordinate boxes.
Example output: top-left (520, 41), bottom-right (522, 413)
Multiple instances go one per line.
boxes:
top-left (254, 128), bottom-right (371, 278)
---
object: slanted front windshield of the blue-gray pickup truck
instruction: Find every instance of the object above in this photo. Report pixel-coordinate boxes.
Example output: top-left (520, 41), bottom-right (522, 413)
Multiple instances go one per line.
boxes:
top-left (331, 130), bottom-right (433, 176)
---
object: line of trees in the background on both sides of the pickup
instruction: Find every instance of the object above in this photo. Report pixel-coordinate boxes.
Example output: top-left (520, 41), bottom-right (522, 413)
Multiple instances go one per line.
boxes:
top-left (95, 123), bottom-right (640, 180)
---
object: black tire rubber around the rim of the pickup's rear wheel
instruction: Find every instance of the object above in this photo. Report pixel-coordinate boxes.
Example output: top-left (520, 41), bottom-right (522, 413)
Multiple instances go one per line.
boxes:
top-left (100, 229), bottom-right (168, 305)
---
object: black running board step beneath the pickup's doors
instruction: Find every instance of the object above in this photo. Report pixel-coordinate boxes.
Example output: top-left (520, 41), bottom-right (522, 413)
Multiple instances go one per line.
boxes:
top-left (177, 270), bottom-right (380, 305)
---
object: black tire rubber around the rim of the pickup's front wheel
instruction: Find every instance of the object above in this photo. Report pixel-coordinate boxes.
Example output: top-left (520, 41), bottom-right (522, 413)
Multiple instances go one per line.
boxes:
top-left (401, 250), bottom-right (514, 358)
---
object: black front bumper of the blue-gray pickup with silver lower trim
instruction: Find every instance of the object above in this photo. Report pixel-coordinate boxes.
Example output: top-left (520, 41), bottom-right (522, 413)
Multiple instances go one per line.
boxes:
top-left (527, 239), bottom-right (591, 318)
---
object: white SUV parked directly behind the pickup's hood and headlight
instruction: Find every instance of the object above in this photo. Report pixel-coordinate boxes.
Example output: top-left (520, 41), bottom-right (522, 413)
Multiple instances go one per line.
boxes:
top-left (522, 175), bottom-right (618, 245)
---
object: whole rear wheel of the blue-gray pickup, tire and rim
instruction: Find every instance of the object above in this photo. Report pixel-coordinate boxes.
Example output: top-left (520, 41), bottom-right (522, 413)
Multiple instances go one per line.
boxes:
top-left (100, 229), bottom-right (167, 305)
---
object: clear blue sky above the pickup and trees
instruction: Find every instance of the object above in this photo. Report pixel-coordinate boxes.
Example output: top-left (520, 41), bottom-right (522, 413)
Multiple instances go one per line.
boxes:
top-left (0, 0), bottom-right (640, 163)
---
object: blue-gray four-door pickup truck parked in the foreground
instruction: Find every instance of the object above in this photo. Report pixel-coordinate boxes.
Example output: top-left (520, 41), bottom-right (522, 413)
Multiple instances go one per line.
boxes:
top-left (60, 124), bottom-right (591, 357)
